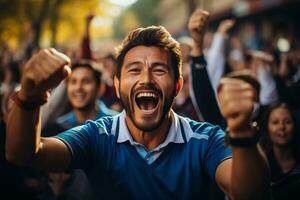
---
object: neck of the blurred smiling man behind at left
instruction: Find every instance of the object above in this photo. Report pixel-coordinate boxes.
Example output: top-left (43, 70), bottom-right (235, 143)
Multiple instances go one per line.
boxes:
top-left (74, 104), bottom-right (99, 124)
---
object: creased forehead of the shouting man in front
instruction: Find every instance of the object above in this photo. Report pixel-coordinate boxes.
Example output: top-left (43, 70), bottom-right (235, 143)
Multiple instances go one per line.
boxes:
top-left (123, 46), bottom-right (170, 64)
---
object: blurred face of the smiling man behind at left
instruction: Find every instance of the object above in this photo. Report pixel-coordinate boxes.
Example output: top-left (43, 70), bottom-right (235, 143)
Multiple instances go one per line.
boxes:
top-left (68, 67), bottom-right (98, 110)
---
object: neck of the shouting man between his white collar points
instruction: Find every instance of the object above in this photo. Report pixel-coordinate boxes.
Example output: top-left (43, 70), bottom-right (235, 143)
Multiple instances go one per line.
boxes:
top-left (125, 112), bottom-right (173, 150)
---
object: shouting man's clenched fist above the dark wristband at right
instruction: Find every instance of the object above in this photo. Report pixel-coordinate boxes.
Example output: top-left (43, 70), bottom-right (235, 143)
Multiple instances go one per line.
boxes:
top-left (218, 78), bottom-right (258, 137)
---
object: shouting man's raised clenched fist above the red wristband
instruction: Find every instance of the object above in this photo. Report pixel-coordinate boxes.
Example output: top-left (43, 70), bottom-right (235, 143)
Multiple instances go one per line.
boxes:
top-left (19, 49), bottom-right (71, 101)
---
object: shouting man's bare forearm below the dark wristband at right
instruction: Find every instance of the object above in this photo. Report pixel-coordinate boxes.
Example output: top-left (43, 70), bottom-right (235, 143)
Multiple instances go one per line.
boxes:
top-left (231, 145), bottom-right (270, 200)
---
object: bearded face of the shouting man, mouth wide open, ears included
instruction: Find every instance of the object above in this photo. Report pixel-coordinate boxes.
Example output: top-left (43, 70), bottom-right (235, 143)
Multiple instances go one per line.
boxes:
top-left (115, 46), bottom-right (182, 131)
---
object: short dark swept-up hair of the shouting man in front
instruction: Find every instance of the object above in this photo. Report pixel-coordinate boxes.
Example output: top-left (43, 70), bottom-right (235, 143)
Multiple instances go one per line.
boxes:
top-left (116, 26), bottom-right (182, 80)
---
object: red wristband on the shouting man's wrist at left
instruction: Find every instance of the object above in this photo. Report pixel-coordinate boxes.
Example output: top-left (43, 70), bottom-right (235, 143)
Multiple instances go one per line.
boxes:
top-left (11, 92), bottom-right (47, 110)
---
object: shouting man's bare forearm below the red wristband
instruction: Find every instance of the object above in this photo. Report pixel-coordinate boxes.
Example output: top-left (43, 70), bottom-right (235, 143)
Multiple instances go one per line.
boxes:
top-left (5, 104), bottom-right (41, 166)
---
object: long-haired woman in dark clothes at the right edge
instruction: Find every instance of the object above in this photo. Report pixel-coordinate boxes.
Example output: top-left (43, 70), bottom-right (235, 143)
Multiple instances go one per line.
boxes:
top-left (260, 103), bottom-right (300, 200)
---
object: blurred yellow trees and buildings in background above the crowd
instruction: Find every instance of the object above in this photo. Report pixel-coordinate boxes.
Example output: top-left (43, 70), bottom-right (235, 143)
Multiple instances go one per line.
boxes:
top-left (0, 0), bottom-right (300, 54)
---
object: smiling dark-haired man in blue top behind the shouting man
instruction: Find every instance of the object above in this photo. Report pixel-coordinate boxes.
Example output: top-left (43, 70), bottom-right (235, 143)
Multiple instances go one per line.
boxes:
top-left (42, 60), bottom-right (117, 136)
